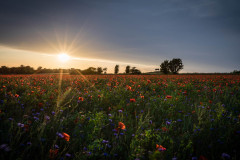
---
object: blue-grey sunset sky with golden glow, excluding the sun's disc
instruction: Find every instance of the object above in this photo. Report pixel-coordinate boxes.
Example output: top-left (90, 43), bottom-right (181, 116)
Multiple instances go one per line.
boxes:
top-left (0, 0), bottom-right (240, 73)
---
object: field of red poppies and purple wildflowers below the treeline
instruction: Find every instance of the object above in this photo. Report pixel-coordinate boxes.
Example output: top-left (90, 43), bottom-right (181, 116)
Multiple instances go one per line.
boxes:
top-left (0, 75), bottom-right (240, 160)
